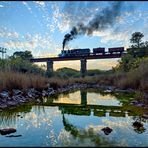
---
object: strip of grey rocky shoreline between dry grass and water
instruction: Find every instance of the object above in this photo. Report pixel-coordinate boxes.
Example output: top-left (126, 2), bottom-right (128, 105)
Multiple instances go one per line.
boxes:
top-left (0, 83), bottom-right (148, 111)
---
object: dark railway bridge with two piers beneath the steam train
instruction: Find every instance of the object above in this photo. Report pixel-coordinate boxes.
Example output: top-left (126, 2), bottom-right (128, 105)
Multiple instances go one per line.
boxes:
top-left (30, 52), bottom-right (125, 77)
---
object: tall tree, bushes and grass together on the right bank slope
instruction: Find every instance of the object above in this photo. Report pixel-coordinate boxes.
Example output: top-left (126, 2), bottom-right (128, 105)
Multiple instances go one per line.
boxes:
top-left (113, 32), bottom-right (148, 93)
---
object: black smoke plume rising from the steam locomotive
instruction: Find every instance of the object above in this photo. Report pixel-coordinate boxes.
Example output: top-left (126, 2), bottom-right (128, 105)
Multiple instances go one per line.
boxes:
top-left (63, 2), bottom-right (123, 50)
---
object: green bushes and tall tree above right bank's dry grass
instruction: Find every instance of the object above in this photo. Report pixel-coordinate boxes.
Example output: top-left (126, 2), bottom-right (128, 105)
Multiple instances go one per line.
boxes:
top-left (114, 32), bottom-right (148, 72)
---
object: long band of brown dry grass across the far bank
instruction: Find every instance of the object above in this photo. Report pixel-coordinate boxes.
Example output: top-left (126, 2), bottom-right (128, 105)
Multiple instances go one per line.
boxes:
top-left (0, 57), bottom-right (148, 96)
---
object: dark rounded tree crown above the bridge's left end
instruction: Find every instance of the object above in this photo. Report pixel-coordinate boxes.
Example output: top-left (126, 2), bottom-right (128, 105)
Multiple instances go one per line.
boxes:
top-left (13, 50), bottom-right (33, 60)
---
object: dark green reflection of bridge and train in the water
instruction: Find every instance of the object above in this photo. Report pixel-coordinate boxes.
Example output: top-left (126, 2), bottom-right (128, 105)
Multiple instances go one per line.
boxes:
top-left (43, 90), bottom-right (145, 117)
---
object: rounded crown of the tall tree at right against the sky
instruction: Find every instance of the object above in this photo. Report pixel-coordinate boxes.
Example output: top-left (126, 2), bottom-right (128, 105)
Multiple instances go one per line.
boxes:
top-left (130, 32), bottom-right (144, 48)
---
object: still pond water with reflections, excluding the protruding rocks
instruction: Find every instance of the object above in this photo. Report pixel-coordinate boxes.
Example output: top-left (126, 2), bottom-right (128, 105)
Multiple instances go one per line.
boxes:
top-left (0, 89), bottom-right (148, 147)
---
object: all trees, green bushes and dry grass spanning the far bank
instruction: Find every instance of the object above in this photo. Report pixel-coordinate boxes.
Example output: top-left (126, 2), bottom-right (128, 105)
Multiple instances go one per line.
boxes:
top-left (0, 32), bottom-right (148, 103)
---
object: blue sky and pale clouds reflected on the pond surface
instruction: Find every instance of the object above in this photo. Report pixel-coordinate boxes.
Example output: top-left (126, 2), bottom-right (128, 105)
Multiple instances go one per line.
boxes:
top-left (0, 91), bottom-right (148, 147)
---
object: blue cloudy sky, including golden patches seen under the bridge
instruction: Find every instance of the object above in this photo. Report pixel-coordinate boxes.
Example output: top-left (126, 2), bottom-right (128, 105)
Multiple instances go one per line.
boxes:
top-left (0, 1), bottom-right (148, 70)
